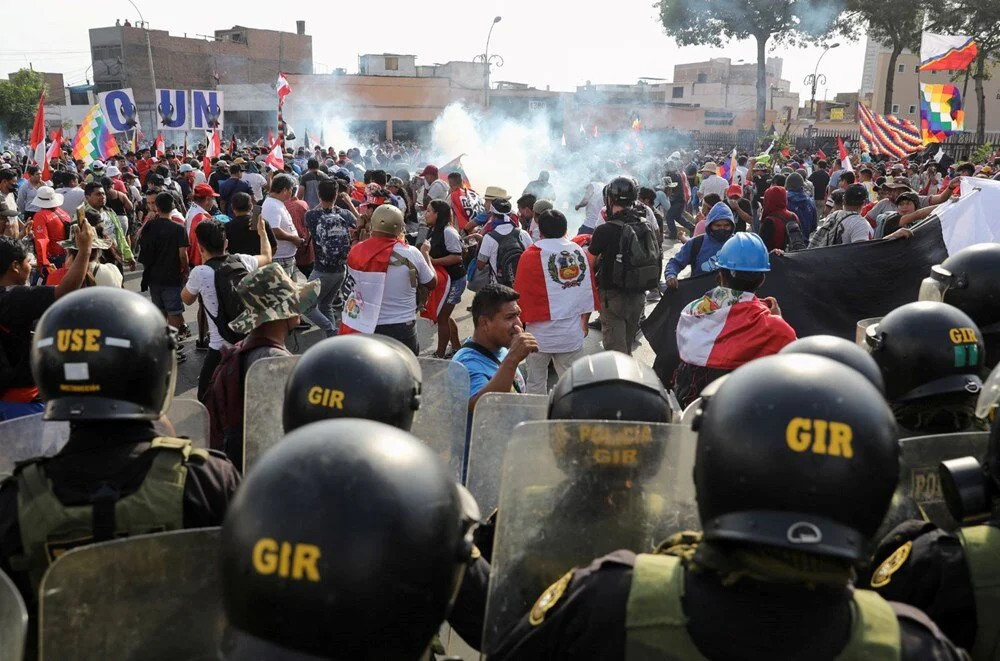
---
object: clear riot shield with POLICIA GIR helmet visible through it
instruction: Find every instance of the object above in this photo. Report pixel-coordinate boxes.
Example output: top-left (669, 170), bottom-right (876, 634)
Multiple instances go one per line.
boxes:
top-left (483, 420), bottom-right (700, 653)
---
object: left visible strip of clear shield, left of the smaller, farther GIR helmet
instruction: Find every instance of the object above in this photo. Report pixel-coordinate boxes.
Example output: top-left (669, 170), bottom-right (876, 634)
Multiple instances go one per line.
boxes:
top-left (242, 356), bottom-right (299, 473)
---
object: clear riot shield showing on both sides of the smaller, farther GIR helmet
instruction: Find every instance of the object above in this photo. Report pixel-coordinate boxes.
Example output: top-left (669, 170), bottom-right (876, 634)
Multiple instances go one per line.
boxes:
top-left (243, 356), bottom-right (469, 478)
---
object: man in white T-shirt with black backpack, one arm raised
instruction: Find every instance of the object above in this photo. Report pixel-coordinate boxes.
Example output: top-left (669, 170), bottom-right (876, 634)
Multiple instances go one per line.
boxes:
top-left (181, 217), bottom-right (271, 401)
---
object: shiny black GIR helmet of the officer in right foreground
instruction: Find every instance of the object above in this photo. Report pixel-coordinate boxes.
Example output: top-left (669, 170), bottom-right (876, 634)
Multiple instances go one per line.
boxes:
top-left (694, 355), bottom-right (899, 561)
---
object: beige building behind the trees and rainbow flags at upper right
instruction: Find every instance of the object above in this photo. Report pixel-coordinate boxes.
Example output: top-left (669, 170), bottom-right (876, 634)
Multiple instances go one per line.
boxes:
top-left (861, 39), bottom-right (1000, 132)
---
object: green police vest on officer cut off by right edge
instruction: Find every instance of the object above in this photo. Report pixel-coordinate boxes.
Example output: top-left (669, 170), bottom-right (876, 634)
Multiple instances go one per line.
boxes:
top-left (958, 526), bottom-right (1000, 661)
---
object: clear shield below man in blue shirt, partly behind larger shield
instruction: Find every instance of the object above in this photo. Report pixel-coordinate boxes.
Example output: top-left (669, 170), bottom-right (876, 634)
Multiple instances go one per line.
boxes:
top-left (465, 392), bottom-right (549, 516)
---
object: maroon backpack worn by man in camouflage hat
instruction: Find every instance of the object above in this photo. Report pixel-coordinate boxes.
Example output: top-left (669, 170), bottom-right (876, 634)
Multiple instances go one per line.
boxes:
top-left (202, 337), bottom-right (285, 466)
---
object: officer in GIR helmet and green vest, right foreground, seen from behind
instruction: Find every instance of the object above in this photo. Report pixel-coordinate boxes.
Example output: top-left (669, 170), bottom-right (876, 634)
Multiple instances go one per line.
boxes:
top-left (490, 355), bottom-right (962, 660)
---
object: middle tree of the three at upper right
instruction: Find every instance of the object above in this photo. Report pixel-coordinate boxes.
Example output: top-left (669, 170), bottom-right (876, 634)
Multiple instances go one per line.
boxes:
top-left (840, 0), bottom-right (924, 115)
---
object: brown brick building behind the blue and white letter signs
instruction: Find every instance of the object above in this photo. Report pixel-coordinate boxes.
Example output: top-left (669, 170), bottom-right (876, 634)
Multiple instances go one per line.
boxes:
top-left (90, 21), bottom-right (313, 127)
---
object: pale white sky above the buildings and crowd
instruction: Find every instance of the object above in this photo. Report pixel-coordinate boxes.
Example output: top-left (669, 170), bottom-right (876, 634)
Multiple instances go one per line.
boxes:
top-left (0, 0), bottom-right (864, 101)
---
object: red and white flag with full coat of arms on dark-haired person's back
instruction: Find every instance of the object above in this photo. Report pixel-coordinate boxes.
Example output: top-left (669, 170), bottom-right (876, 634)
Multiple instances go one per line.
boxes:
top-left (514, 239), bottom-right (601, 324)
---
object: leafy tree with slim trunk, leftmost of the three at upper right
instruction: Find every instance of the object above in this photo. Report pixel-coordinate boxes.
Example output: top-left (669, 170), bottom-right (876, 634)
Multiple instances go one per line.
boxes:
top-left (658, 0), bottom-right (844, 127)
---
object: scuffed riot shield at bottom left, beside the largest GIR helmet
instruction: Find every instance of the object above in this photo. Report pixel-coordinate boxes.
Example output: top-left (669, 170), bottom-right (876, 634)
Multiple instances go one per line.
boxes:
top-left (39, 528), bottom-right (225, 661)
